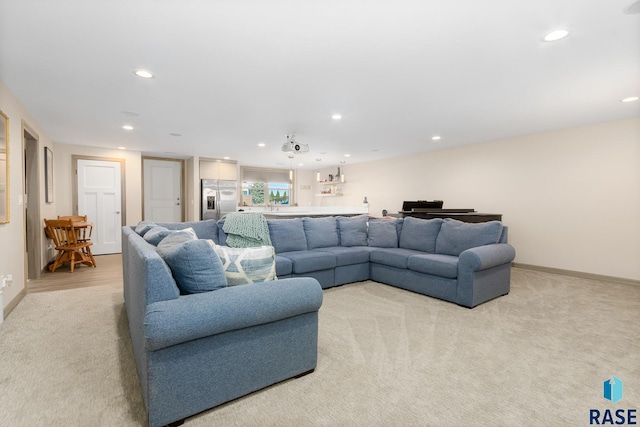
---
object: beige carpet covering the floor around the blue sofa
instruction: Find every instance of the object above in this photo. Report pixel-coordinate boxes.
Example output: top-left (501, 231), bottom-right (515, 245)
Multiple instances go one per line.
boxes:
top-left (0, 269), bottom-right (640, 426)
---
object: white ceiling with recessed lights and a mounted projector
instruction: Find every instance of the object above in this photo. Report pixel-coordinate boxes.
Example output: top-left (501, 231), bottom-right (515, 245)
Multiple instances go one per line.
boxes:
top-left (0, 0), bottom-right (640, 168)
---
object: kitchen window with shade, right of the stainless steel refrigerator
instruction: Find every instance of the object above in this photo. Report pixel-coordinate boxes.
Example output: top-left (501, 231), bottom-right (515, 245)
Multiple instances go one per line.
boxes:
top-left (240, 167), bottom-right (293, 206)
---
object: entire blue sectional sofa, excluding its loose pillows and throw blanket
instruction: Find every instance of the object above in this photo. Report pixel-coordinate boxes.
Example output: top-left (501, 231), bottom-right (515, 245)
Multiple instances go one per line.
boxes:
top-left (123, 216), bottom-right (515, 426)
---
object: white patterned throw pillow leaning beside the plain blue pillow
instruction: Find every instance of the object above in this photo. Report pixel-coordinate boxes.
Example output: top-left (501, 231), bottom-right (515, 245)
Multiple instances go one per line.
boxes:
top-left (214, 244), bottom-right (276, 286)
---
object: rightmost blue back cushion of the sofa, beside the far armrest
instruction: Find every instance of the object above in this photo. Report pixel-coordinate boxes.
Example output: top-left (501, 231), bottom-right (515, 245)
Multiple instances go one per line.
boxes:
top-left (436, 218), bottom-right (502, 256)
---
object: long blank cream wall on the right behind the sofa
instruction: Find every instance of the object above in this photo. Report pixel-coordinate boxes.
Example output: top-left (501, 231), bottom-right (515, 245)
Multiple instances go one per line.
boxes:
top-left (333, 118), bottom-right (640, 280)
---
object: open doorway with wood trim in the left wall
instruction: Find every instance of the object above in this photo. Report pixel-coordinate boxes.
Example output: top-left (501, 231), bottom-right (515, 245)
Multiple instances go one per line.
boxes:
top-left (22, 121), bottom-right (43, 280)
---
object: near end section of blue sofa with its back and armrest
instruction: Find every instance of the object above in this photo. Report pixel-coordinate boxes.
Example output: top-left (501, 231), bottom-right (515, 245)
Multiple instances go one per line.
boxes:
top-left (122, 224), bottom-right (322, 426)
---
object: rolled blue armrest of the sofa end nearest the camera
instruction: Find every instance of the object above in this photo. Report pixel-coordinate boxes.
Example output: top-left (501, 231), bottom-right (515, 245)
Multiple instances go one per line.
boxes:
top-left (145, 277), bottom-right (322, 351)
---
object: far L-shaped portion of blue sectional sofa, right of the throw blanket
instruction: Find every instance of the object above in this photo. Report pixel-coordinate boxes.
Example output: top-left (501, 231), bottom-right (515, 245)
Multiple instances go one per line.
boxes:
top-left (264, 216), bottom-right (515, 308)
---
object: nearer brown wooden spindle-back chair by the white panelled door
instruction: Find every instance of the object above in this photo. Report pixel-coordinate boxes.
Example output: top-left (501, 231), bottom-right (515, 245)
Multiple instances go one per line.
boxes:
top-left (44, 219), bottom-right (96, 273)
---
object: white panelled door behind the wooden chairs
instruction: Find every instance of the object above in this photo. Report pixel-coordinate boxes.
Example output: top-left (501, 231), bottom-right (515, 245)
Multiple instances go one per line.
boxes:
top-left (77, 159), bottom-right (122, 255)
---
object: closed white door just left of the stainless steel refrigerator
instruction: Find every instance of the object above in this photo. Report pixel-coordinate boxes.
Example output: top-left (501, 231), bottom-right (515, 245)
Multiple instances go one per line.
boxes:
top-left (142, 159), bottom-right (182, 222)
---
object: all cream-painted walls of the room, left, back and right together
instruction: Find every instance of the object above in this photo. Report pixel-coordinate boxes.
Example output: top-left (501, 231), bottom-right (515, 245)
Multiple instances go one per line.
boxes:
top-left (0, 72), bottom-right (640, 320)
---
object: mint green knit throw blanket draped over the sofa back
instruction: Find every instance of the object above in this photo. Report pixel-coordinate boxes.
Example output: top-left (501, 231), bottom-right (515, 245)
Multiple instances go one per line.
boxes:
top-left (222, 212), bottom-right (271, 248)
